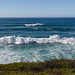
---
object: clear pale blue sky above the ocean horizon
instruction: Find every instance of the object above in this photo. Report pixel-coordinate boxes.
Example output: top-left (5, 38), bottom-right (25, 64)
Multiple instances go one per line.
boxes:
top-left (0, 0), bottom-right (75, 17)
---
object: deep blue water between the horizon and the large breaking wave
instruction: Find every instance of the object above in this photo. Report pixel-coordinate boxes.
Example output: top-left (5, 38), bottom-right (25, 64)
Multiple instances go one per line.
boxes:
top-left (0, 18), bottom-right (75, 37)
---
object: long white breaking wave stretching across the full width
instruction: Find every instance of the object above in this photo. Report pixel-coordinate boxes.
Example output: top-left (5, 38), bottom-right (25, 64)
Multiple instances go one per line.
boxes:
top-left (0, 35), bottom-right (75, 44)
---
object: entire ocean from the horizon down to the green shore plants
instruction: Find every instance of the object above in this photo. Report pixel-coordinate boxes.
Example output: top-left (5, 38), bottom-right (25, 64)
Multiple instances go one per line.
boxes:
top-left (0, 18), bottom-right (75, 64)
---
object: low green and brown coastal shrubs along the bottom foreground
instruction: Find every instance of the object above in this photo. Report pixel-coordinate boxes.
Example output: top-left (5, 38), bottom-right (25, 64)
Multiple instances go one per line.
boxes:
top-left (0, 59), bottom-right (75, 75)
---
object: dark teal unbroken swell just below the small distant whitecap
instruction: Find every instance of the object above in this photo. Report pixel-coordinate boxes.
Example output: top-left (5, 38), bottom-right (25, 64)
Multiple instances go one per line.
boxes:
top-left (0, 26), bottom-right (75, 31)
